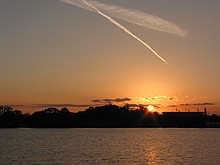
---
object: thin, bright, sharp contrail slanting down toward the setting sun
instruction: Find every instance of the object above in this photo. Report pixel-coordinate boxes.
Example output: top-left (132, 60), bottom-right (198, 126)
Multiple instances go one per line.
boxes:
top-left (82, 0), bottom-right (169, 65)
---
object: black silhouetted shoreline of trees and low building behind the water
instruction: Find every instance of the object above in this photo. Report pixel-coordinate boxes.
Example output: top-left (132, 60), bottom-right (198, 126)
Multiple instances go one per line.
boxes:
top-left (0, 104), bottom-right (220, 128)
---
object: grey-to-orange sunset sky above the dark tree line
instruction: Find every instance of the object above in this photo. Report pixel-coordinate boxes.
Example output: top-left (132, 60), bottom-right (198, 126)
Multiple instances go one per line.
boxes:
top-left (0, 0), bottom-right (220, 114)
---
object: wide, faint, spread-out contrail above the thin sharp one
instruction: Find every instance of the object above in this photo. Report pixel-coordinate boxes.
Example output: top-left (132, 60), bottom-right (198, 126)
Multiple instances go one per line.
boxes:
top-left (60, 0), bottom-right (187, 37)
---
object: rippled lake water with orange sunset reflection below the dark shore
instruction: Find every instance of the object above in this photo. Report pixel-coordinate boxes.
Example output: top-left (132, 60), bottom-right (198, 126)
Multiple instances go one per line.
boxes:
top-left (0, 128), bottom-right (220, 165)
